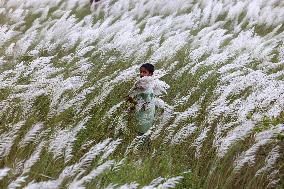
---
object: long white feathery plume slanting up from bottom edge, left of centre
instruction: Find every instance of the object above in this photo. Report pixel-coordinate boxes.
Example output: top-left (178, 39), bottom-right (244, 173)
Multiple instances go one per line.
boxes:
top-left (68, 161), bottom-right (114, 189)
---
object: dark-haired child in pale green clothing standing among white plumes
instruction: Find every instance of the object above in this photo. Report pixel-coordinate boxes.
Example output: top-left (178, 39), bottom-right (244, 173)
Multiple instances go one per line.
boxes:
top-left (127, 63), bottom-right (155, 135)
